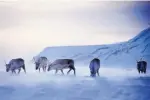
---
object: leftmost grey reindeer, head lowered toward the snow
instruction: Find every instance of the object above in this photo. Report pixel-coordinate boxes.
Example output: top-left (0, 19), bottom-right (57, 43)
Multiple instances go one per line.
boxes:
top-left (5, 58), bottom-right (26, 74)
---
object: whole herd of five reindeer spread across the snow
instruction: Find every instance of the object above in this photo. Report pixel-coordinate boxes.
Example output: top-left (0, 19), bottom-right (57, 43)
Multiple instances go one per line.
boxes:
top-left (5, 57), bottom-right (147, 77)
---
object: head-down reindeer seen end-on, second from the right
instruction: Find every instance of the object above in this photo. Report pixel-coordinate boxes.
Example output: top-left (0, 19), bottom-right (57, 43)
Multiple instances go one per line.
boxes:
top-left (89, 58), bottom-right (100, 77)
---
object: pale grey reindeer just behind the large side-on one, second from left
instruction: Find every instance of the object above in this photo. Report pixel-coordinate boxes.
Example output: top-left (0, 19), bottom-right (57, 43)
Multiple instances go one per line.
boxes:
top-left (33, 57), bottom-right (48, 72)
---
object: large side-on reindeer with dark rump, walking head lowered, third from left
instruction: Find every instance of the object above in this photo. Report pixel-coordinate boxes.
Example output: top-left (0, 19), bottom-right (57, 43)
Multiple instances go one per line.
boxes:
top-left (47, 59), bottom-right (76, 75)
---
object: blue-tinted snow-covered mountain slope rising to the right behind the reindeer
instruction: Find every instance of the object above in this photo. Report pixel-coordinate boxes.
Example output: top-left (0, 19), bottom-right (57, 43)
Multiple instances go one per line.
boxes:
top-left (36, 27), bottom-right (150, 67)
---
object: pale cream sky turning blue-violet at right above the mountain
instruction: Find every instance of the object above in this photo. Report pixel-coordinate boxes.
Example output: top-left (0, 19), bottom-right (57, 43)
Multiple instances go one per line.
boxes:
top-left (0, 0), bottom-right (150, 65)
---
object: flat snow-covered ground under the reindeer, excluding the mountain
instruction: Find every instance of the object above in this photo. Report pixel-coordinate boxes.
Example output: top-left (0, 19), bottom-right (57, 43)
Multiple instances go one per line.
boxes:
top-left (0, 67), bottom-right (150, 100)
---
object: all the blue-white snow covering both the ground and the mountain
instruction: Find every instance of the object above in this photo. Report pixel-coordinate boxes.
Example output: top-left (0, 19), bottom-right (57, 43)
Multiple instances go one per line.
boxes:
top-left (0, 28), bottom-right (150, 100)
